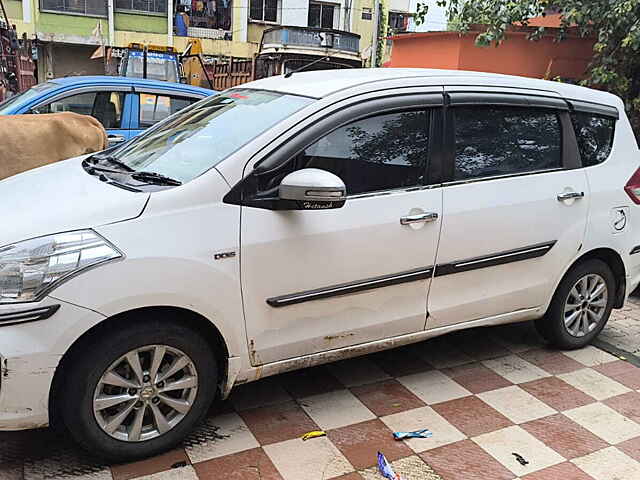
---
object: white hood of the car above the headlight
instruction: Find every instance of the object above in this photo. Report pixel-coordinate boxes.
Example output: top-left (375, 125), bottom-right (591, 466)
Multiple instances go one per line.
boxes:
top-left (0, 156), bottom-right (149, 246)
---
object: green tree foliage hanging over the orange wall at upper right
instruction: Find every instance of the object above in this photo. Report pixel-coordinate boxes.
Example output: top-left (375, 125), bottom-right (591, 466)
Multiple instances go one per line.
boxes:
top-left (417, 0), bottom-right (640, 136)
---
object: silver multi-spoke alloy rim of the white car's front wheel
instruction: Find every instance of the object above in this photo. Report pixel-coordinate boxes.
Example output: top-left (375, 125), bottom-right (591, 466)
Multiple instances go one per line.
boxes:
top-left (93, 345), bottom-right (198, 442)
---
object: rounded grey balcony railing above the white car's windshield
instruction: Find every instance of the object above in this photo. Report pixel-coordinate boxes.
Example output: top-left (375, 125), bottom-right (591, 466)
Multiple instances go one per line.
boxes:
top-left (262, 27), bottom-right (360, 54)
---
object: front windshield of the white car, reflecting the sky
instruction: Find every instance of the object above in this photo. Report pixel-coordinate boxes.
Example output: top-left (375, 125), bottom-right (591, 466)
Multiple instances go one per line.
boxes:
top-left (110, 89), bottom-right (313, 183)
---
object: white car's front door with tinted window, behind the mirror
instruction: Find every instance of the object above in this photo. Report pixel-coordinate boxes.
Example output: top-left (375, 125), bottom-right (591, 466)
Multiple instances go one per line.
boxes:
top-left (241, 98), bottom-right (442, 365)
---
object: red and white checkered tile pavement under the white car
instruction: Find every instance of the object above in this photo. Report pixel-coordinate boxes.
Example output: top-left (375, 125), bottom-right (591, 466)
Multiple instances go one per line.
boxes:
top-left (0, 324), bottom-right (640, 480)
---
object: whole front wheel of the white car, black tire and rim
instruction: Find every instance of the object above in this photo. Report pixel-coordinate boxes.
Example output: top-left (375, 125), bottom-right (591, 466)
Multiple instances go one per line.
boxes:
top-left (61, 318), bottom-right (218, 462)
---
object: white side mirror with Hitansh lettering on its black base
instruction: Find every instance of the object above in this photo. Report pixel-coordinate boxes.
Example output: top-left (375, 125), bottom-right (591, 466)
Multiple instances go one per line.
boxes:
top-left (278, 168), bottom-right (347, 210)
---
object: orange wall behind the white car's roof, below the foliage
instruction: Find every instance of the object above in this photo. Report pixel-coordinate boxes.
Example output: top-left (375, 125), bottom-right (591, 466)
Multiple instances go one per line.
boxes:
top-left (387, 32), bottom-right (593, 79)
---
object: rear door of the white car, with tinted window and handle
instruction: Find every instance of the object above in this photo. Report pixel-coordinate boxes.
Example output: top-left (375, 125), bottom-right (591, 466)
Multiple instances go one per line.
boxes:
top-left (427, 89), bottom-right (589, 328)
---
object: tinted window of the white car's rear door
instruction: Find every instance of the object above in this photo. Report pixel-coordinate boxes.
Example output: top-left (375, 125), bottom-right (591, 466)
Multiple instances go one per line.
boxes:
top-left (454, 106), bottom-right (562, 180)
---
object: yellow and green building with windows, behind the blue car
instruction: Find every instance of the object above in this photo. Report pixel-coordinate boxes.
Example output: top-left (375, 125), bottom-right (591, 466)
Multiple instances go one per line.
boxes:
top-left (4, 0), bottom-right (396, 81)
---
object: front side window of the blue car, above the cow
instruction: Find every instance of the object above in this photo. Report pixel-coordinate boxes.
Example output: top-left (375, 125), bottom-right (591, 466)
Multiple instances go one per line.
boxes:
top-left (33, 92), bottom-right (125, 129)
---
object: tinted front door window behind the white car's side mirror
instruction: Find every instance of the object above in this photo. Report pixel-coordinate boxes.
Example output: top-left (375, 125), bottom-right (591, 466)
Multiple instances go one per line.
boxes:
top-left (292, 110), bottom-right (429, 195)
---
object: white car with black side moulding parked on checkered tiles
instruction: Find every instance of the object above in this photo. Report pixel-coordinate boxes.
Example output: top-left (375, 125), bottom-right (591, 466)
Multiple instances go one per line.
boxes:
top-left (0, 69), bottom-right (640, 461)
